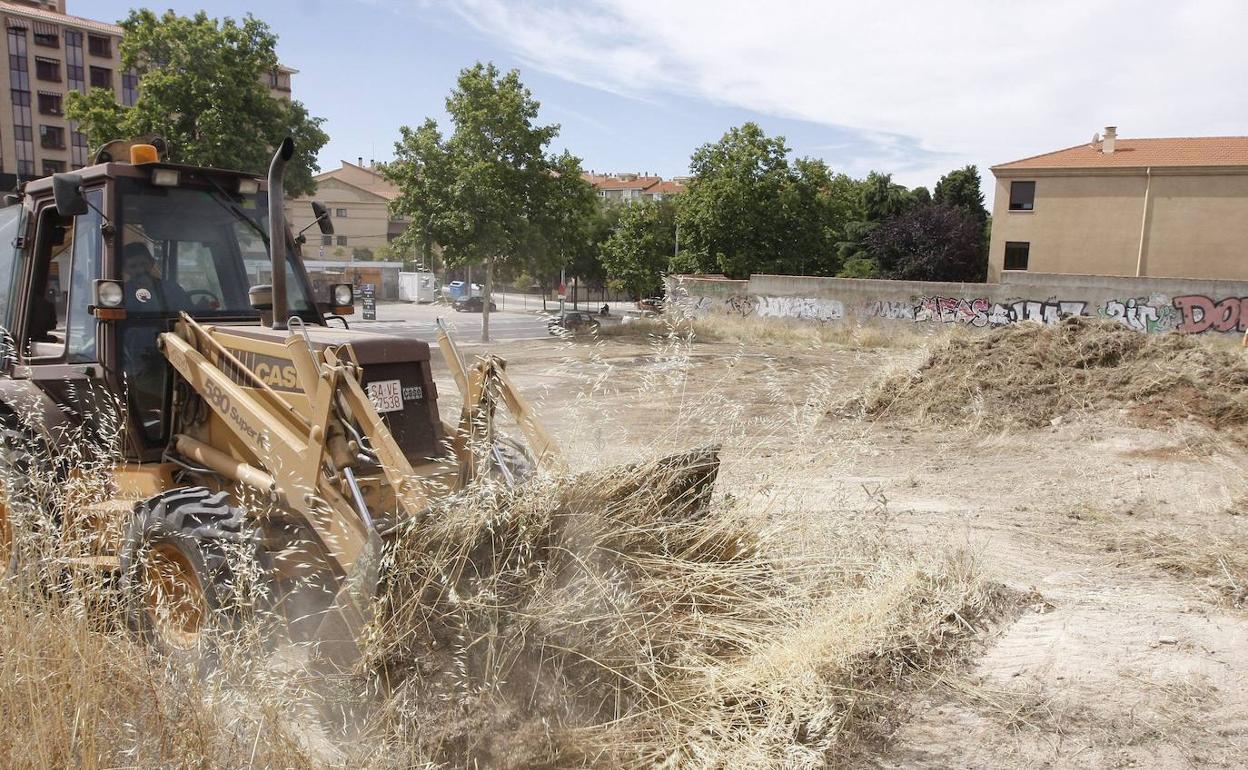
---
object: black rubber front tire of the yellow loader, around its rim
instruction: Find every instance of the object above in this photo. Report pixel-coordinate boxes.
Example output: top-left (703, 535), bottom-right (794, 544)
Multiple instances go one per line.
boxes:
top-left (121, 487), bottom-right (272, 661)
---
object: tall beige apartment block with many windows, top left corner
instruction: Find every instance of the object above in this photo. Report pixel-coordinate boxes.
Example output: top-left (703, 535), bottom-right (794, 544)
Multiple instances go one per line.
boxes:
top-left (0, 0), bottom-right (296, 190)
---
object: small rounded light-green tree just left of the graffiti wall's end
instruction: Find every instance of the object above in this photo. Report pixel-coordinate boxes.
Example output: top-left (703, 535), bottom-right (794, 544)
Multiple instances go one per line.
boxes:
top-left (602, 201), bottom-right (676, 300)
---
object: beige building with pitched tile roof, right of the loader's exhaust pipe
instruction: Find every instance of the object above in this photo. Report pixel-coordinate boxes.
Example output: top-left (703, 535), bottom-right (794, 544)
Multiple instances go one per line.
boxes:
top-left (286, 158), bottom-right (407, 260)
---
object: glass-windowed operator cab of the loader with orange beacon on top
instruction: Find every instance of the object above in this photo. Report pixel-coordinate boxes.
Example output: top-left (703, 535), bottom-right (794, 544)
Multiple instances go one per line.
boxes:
top-left (0, 142), bottom-right (328, 459)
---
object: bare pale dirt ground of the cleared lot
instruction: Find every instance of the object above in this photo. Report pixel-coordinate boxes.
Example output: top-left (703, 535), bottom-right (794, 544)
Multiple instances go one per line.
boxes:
top-left (436, 331), bottom-right (1248, 768)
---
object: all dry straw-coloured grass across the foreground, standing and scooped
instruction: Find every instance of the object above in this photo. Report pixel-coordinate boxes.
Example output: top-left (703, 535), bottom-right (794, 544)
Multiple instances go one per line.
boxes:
top-left (0, 341), bottom-right (1007, 768)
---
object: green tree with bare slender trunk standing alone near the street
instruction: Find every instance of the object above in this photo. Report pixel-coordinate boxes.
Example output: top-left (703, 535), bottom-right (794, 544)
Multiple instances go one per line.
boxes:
top-left (382, 62), bottom-right (593, 341)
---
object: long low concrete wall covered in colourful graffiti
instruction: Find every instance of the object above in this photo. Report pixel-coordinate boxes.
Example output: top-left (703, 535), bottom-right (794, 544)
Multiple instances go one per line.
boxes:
top-left (668, 271), bottom-right (1248, 334)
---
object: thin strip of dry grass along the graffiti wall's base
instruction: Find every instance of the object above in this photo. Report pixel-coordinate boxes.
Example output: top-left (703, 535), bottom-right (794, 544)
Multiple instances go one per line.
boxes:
top-left (599, 311), bottom-right (924, 349)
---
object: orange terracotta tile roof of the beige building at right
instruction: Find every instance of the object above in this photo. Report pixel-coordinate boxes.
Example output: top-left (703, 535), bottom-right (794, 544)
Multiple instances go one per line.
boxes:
top-left (992, 136), bottom-right (1248, 171)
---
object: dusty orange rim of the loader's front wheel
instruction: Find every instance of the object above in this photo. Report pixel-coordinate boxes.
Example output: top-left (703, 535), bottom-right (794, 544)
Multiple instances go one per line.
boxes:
top-left (144, 544), bottom-right (208, 650)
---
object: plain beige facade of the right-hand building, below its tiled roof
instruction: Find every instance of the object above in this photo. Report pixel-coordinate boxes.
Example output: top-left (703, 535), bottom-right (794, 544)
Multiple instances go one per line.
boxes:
top-left (988, 168), bottom-right (1248, 281)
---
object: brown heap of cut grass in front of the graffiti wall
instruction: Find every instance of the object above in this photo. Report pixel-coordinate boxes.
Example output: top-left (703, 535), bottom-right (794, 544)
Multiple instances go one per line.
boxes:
top-left (852, 317), bottom-right (1248, 428)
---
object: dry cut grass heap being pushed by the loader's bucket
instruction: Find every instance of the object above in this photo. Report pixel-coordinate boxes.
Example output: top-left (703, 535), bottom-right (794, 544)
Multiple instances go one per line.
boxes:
top-left (371, 446), bottom-right (1005, 769)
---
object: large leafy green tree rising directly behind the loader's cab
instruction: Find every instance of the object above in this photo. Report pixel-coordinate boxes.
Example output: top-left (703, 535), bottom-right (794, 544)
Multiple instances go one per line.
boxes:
top-left (65, 9), bottom-right (329, 195)
